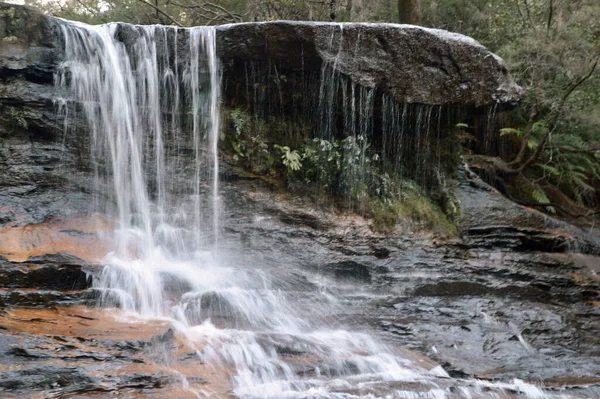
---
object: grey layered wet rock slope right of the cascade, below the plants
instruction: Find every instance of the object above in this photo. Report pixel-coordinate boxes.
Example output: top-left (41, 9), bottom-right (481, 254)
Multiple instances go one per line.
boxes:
top-left (211, 170), bottom-right (600, 397)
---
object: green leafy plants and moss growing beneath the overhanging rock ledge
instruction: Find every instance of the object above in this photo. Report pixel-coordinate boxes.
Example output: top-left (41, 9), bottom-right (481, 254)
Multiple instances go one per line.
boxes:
top-left (225, 108), bottom-right (459, 236)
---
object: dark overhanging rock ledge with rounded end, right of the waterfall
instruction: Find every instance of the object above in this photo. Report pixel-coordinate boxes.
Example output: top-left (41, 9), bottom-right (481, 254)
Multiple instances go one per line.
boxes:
top-left (217, 21), bottom-right (521, 105)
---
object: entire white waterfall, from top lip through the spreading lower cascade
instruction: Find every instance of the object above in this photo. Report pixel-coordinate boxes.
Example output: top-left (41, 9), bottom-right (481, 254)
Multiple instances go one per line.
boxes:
top-left (56, 19), bottom-right (568, 398)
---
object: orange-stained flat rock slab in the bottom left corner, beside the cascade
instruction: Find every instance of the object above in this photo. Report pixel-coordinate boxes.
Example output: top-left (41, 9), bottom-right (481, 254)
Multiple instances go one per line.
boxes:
top-left (0, 307), bottom-right (229, 399)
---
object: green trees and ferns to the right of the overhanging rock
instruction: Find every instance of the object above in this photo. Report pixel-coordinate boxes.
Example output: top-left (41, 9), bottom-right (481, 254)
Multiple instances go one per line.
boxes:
top-left (424, 0), bottom-right (600, 220)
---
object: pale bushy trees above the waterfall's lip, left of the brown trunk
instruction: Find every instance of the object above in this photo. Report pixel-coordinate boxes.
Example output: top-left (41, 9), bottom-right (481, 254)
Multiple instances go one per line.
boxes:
top-left (25, 0), bottom-right (408, 26)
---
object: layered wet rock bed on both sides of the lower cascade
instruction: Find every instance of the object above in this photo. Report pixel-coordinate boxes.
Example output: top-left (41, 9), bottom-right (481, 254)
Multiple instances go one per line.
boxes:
top-left (0, 164), bottom-right (600, 398)
